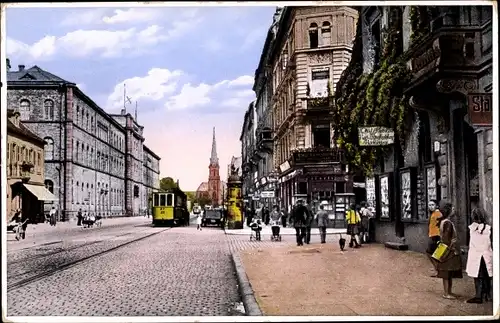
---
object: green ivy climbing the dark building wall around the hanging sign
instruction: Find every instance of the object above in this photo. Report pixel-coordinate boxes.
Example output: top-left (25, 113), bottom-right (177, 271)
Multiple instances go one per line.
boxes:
top-left (333, 9), bottom-right (412, 176)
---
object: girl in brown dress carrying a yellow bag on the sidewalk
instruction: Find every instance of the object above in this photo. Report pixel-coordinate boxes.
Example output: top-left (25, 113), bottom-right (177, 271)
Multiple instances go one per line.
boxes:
top-left (436, 201), bottom-right (462, 299)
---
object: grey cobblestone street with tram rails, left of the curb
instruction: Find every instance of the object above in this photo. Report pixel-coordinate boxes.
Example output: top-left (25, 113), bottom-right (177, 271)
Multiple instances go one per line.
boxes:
top-left (8, 219), bottom-right (243, 316)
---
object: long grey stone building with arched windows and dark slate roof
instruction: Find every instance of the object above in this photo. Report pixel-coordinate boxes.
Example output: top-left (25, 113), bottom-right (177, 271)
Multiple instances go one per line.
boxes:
top-left (7, 62), bottom-right (159, 220)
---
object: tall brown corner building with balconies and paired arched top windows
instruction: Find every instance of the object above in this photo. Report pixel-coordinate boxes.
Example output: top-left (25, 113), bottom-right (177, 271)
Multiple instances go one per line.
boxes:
top-left (256, 6), bottom-right (358, 213)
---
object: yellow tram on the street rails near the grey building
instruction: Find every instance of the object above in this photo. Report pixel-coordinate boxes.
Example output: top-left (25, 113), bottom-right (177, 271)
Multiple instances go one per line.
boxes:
top-left (151, 188), bottom-right (189, 226)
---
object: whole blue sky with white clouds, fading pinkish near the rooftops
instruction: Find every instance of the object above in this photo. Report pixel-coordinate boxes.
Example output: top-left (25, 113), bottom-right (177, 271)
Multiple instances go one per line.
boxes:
top-left (6, 5), bottom-right (275, 190)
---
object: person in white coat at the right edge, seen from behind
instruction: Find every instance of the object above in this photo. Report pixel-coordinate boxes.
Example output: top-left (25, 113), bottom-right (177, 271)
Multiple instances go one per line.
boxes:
top-left (466, 208), bottom-right (493, 304)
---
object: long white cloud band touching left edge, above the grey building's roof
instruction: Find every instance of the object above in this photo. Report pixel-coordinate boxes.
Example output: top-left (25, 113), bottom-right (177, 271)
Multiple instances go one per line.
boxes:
top-left (6, 25), bottom-right (169, 62)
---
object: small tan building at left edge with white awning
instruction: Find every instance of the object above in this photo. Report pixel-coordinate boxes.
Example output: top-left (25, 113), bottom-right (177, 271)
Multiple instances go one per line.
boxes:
top-left (6, 109), bottom-right (56, 223)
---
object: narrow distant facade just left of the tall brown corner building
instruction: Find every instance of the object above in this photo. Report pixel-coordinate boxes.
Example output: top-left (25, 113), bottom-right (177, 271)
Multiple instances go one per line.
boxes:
top-left (240, 102), bottom-right (258, 207)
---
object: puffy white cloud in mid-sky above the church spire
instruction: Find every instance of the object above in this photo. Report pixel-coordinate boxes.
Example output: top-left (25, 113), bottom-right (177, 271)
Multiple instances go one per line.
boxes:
top-left (106, 68), bottom-right (255, 112)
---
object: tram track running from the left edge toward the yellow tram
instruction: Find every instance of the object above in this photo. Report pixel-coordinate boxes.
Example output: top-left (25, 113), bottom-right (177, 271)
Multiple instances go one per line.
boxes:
top-left (7, 228), bottom-right (172, 291)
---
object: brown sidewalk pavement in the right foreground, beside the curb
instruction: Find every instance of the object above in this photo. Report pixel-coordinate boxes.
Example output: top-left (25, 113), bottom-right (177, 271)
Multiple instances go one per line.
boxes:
top-left (240, 240), bottom-right (493, 316)
